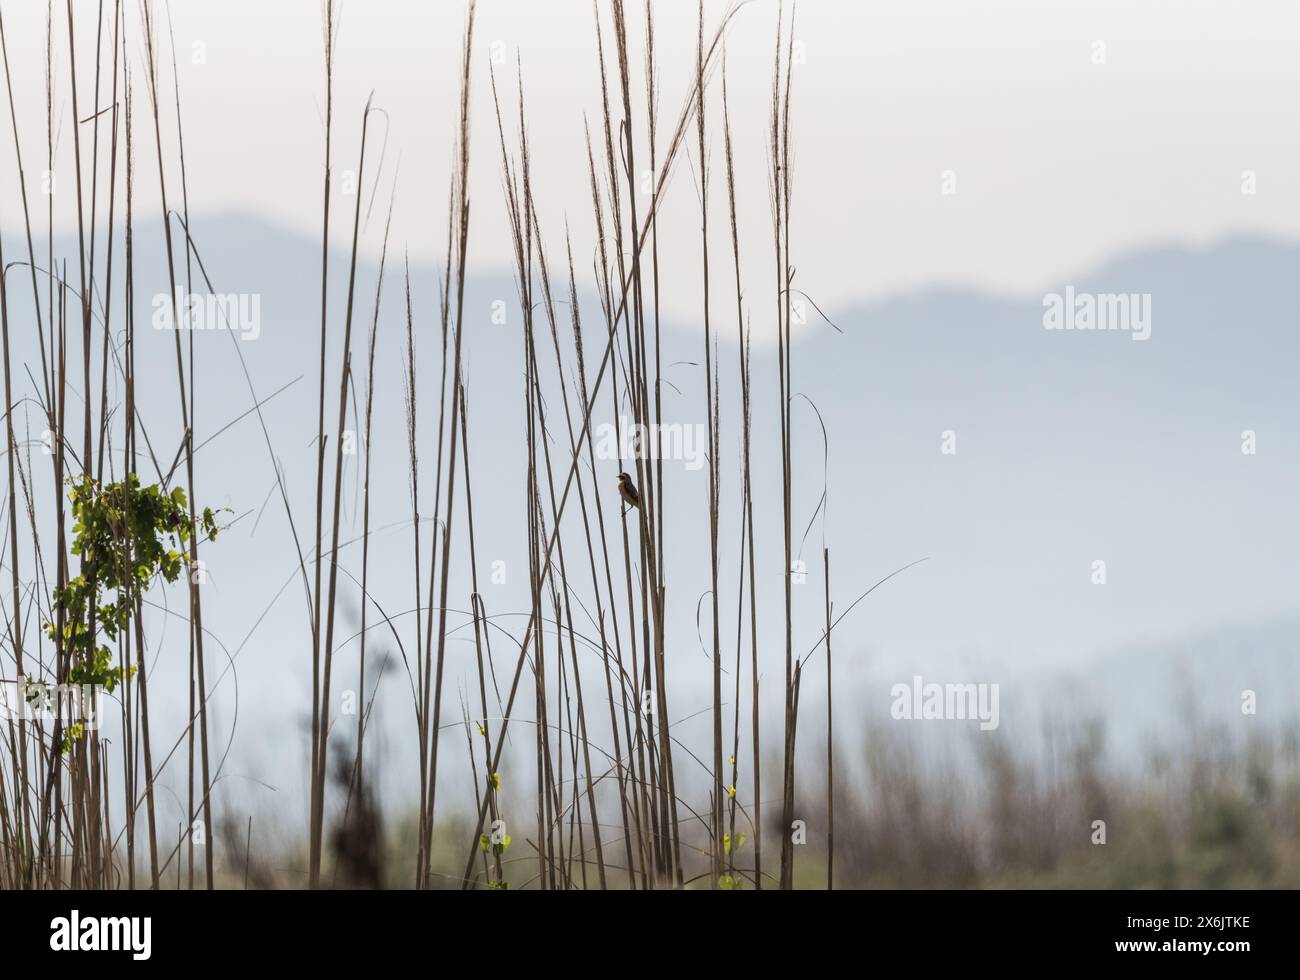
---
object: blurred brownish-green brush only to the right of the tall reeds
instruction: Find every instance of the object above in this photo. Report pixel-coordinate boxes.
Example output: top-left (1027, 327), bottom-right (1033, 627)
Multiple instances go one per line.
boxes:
top-left (816, 723), bottom-right (1300, 889)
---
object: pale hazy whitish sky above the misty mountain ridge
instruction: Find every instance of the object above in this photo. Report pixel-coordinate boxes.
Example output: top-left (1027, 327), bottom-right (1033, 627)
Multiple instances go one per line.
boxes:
top-left (0, 0), bottom-right (1300, 330)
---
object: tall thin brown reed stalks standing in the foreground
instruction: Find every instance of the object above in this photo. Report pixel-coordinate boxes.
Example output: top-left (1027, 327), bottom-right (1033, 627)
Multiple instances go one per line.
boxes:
top-left (0, 0), bottom-right (861, 889)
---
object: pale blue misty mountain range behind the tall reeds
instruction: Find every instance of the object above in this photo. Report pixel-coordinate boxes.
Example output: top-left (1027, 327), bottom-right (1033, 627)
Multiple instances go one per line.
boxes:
top-left (7, 216), bottom-right (1300, 811)
